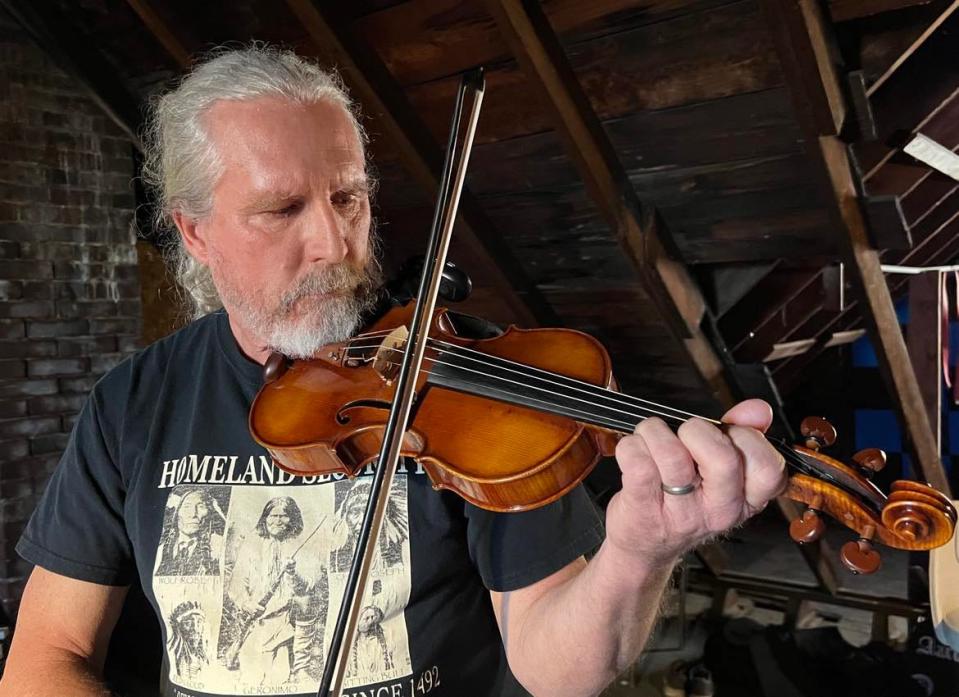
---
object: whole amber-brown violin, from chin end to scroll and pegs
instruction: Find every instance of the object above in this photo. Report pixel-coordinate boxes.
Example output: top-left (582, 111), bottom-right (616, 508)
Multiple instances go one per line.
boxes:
top-left (250, 304), bottom-right (956, 573)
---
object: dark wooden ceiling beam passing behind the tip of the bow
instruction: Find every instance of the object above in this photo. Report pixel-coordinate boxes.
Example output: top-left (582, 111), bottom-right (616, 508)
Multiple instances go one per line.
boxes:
top-left (287, 0), bottom-right (557, 326)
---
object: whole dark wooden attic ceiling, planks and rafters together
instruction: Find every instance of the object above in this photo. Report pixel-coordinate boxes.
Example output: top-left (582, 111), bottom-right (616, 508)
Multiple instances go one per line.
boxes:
top-left (9, 0), bottom-right (959, 591)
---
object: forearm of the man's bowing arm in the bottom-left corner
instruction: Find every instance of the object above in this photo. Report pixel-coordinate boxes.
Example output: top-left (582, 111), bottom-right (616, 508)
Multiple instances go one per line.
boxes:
top-left (0, 650), bottom-right (110, 697)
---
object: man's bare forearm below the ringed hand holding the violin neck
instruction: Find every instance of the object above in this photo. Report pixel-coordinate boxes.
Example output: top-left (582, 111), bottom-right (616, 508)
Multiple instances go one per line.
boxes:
top-left (510, 544), bottom-right (673, 697)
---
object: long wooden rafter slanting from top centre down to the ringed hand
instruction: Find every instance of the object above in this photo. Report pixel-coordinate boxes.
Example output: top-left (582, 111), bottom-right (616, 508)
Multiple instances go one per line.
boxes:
top-left (487, 0), bottom-right (839, 593)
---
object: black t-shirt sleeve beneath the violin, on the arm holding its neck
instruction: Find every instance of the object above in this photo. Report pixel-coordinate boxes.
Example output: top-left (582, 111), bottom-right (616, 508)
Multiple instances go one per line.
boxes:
top-left (466, 486), bottom-right (605, 592)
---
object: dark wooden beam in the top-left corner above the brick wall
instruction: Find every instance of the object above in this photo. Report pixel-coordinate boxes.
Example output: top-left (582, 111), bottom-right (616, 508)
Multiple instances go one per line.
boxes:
top-left (0, 0), bottom-right (143, 151)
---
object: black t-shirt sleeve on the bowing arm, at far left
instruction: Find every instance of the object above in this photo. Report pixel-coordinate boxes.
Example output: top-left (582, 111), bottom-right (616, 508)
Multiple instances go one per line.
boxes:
top-left (17, 390), bottom-right (134, 586)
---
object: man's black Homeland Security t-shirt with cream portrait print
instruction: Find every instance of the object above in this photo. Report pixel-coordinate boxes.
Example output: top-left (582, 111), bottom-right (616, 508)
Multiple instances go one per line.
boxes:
top-left (17, 312), bottom-right (602, 697)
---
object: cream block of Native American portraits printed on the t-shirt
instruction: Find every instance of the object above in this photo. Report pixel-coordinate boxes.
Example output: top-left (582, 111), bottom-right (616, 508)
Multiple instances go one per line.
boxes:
top-left (153, 456), bottom-right (412, 695)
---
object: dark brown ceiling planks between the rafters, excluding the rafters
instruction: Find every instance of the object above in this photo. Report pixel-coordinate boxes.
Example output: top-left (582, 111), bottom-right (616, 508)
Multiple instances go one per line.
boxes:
top-left (35, 0), bottom-right (848, 413)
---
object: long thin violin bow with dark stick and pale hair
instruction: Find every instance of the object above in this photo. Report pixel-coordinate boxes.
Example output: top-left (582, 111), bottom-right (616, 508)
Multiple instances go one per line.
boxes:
top-left (316, 68), bottom-right (485, 697)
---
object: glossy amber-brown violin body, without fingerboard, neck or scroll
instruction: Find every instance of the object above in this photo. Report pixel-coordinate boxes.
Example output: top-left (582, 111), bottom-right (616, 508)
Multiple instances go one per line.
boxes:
top-left (250, 305), bottom-right (620, 511)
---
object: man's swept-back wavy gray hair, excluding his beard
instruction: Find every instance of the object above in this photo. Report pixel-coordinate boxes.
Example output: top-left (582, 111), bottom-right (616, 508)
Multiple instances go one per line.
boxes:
top-left (141, 43), bottom-right (367, 318)
